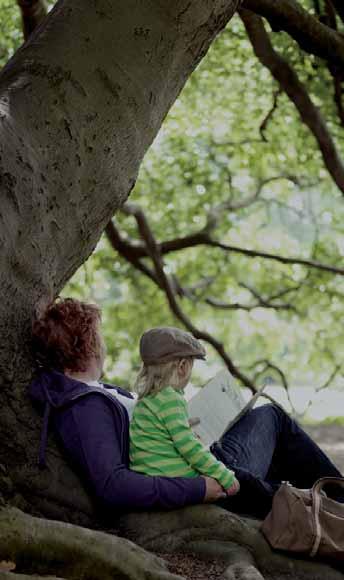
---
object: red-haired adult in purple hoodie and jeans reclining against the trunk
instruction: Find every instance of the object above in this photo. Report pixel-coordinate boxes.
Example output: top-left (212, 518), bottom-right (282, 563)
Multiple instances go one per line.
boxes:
top-left (30, 298), bottom-right (340, 517)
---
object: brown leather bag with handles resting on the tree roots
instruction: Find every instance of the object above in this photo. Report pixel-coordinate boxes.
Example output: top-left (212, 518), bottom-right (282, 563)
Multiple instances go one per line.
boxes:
top-left (261, 477), bottom-right (344, 561)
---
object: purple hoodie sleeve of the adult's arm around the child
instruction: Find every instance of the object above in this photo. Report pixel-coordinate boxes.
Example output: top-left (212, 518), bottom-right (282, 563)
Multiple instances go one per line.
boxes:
top-left (55, 395), bottom-right (205, 509)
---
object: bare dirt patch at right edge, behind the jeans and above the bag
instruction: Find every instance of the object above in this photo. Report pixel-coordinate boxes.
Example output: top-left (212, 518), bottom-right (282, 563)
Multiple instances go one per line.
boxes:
top-left (303, 424), bottom-right (344, 474)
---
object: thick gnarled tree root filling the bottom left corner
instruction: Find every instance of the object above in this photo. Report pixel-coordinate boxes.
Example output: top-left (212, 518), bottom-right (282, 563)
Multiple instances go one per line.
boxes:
top-left (0, 507), bottom-right (181, 580)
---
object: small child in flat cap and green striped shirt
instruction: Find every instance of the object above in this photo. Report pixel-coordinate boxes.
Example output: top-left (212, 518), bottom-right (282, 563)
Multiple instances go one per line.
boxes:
top-left (130, 327), bottom-right (240, 495)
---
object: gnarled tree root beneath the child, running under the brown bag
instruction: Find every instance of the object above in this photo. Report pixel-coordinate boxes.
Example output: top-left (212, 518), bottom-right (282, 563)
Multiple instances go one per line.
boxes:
top-left (121, 505), bottom-right (344, 580)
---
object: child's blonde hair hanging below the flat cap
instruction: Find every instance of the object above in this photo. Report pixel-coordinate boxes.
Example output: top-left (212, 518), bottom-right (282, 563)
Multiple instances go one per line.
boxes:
top-left (134, 358), bottom-right (188, 399)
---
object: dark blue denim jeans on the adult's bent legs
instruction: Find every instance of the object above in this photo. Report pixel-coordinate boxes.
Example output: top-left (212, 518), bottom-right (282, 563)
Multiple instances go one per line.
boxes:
top-left (211, 405), bottom-right (344, 517)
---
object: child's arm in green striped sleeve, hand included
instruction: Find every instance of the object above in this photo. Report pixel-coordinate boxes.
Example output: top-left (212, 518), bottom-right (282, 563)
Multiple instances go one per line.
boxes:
top-left (161, 387), bottom-right (235, 489)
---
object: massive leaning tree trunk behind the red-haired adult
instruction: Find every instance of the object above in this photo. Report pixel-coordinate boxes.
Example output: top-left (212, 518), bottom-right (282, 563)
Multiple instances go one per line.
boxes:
top-left (0, 0), bottom-right (239, 524)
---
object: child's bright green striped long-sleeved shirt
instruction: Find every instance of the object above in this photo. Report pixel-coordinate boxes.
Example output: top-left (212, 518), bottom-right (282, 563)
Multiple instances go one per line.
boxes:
top-left (130, 387), bottom-right (234, 489)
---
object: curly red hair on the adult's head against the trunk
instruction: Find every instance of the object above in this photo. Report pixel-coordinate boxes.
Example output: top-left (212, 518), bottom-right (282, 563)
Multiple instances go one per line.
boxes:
top-left (32, 298), bottom-right (101, 372)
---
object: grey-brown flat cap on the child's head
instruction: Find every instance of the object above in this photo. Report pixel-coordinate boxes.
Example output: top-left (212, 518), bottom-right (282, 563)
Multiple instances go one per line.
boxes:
top-left (140, 326), bottom-right (206, 365)
